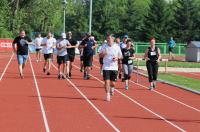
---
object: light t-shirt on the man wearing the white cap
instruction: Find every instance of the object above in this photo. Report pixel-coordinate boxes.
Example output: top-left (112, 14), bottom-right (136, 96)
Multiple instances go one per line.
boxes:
top-left (56, 39), bottom-right (70, 56)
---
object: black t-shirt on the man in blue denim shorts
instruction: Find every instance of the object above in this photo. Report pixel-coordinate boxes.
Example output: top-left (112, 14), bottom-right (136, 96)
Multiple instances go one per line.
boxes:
top-left (13, 36), bottom-right (32, 55)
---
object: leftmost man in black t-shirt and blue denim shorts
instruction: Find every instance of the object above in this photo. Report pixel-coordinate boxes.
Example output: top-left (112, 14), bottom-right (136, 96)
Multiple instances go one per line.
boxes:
top-left (12, 30), bottom-right (32, 79)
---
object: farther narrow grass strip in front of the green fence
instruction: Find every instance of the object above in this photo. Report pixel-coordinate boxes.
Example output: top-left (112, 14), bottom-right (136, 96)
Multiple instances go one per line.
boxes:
top-left (134, 61), bottom-right (200, 68)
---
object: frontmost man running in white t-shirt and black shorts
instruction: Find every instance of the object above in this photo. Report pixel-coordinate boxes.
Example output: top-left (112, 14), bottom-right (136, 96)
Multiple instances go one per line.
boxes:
top-left (99, 35), bottom-right (122, 101)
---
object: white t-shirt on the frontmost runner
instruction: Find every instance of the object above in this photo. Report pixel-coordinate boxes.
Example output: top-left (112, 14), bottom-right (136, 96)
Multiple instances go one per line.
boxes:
top-left (100, 43), bottom-right (122, 71)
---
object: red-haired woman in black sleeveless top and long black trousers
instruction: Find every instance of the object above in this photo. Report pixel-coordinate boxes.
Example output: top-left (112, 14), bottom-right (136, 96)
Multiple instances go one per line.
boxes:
top-left (144, 38), bottom-right (161, 90)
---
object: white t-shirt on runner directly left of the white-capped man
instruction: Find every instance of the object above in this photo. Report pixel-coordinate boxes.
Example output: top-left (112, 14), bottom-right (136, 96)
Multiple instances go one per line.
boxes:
top-left (42, 37), bottom-right (56, 54)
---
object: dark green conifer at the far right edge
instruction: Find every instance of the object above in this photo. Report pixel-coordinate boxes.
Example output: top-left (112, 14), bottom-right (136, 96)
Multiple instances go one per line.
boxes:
top-left (174, 0), bottom-right (199, 42)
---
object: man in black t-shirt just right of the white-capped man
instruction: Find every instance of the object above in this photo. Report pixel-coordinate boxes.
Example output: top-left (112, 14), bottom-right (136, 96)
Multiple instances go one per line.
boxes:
top-left (67, 31), bottom-right (77, 77)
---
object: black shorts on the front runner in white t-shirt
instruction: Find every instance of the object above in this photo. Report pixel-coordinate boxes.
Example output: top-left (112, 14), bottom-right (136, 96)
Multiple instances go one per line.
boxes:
top-left (103, 70), bottom-right (118, 82)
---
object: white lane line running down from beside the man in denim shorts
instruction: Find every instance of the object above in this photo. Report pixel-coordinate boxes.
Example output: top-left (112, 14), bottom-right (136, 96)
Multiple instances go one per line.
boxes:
top-left (29, 56), bottom-right (50, 132)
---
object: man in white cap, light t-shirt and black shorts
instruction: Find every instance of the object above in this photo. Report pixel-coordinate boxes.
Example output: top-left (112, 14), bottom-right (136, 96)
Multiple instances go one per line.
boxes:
top-left (56, 33), bottom-right (71, 79)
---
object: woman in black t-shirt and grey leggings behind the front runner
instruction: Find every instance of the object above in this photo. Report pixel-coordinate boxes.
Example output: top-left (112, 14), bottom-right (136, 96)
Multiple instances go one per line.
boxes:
top-left (122, 40), bottom-right (135, 90)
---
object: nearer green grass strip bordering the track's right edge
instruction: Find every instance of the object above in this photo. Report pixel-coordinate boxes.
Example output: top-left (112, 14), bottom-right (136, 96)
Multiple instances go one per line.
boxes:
top-left (159, 73), bottom-right (200, 91)
